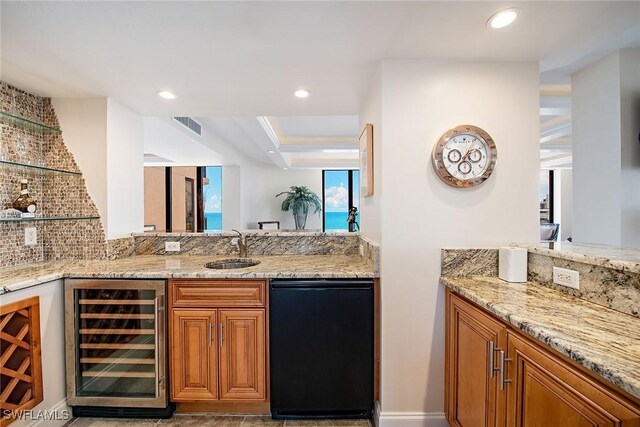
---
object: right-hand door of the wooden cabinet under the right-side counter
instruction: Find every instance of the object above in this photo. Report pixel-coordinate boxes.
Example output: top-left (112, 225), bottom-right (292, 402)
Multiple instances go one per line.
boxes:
top-left (507, 332), bottom-right (640, 427)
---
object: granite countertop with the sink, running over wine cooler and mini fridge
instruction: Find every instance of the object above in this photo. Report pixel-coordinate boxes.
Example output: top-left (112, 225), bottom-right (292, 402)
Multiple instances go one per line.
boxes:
top-left (0, 255), bottom-right (379, 290)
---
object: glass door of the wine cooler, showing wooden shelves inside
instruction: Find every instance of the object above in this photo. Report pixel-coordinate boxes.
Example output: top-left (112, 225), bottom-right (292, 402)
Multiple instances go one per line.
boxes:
top-left (67, 280), bottom-right (166, 406)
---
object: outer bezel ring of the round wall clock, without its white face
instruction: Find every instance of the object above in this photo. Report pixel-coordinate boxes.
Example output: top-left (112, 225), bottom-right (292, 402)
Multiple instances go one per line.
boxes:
top-left (431, 125), bottom-right (498, 188)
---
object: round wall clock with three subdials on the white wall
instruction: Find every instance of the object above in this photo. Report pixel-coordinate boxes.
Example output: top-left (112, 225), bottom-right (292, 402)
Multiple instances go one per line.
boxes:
top-left (431, 125), bottom-right (498, 187)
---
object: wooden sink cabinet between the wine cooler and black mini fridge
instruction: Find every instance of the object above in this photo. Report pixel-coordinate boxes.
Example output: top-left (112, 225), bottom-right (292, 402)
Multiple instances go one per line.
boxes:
top-left (169, 280), bottom-right (267, 402)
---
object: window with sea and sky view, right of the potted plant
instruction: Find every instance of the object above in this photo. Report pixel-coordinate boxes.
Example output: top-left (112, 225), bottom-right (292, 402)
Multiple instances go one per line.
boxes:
top-left (322, 170), bottom-right (360, 231)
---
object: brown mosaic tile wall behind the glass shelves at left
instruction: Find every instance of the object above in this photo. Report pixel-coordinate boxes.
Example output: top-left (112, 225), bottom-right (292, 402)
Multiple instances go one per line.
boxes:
top-left (0, 82), bottom-right (107, 267)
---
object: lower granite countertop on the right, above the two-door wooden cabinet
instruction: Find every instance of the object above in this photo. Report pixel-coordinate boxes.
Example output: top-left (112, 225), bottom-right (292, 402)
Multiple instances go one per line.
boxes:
top-left (440, 276), bottom-right (640, 399)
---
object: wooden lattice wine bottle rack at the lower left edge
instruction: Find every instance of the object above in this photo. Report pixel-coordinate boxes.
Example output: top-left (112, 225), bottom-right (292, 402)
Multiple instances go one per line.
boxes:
top-left (0, 297), bottom-right (43, 426)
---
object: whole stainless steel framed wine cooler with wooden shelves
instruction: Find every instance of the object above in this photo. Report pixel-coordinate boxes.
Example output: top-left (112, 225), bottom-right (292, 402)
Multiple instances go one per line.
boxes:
top-left (64, 279), bottom-right (169, 416)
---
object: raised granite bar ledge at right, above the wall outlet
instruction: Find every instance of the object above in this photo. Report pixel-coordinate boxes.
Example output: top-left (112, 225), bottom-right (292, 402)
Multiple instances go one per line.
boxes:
top-left (517, 242), bottom-right (640, 273)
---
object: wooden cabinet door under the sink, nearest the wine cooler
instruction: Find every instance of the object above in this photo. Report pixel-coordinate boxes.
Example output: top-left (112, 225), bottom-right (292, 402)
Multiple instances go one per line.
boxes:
top-left (170, 309), bottom-right (218, 401)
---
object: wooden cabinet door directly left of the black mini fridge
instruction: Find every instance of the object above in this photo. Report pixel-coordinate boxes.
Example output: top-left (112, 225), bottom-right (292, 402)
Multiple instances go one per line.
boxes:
top-left (219, 309), bottom-right (266, 400)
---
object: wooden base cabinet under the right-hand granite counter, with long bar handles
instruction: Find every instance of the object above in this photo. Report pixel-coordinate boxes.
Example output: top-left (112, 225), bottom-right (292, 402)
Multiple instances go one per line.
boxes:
top-left (445, 290), bottom-right (640, 427)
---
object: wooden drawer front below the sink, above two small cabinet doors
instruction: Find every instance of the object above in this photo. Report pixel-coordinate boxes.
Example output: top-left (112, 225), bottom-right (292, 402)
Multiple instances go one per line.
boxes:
top-left (171, 279), bottom-right (266, 307)
